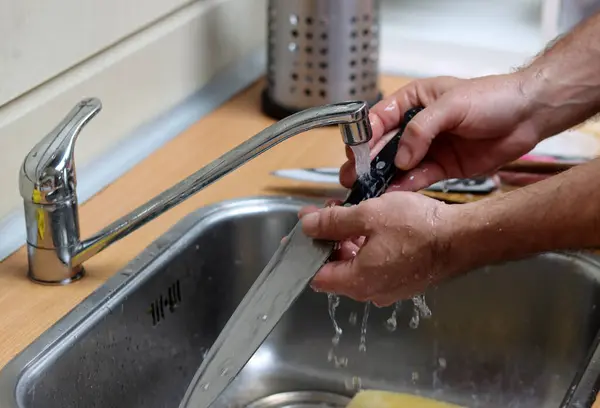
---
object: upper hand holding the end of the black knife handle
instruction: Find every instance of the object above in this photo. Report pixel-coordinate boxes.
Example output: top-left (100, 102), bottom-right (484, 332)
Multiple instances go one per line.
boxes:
top-left (340, 72), bottom-right (542, 191)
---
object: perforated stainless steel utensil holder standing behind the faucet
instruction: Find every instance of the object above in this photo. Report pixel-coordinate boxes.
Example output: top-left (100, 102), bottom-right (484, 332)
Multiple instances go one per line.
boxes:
top-left (262, 0), bottom-right (381, 120)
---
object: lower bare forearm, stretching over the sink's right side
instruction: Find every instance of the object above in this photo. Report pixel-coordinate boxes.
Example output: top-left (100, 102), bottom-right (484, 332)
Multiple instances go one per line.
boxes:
top-left (450, 159), bottom-right (600, 269)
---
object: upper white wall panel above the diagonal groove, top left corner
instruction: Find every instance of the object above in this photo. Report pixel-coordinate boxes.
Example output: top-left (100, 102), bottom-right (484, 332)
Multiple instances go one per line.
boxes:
top-left (0, 0), bottom-right (189, 105)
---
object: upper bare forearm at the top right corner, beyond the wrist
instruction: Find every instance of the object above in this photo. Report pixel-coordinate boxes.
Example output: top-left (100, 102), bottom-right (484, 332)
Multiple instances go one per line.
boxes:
top-left (519, 14), bottom-right (600, 138)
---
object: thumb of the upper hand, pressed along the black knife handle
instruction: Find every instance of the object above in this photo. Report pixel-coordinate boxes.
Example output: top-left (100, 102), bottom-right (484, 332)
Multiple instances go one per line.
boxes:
top-left (395, 98), bottom-right (464, 170)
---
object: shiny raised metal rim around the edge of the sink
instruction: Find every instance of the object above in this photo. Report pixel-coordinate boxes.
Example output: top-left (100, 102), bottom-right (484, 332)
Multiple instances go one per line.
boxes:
top-left (0, 195), bottom-right (600, 408)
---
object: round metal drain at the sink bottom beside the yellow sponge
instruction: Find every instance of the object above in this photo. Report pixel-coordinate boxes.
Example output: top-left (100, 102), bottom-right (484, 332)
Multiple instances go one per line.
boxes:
top-left (246, 391), bottom-right (350, 408)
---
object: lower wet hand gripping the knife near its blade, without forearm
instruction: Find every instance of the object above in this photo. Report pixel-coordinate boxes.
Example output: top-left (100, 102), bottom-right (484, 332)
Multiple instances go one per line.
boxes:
top-left (300, 192), bottom-right (458, 306)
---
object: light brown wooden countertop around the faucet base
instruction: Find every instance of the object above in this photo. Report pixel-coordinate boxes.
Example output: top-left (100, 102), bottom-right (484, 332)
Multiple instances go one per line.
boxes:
top-left (0, 77), bottom-right (600, 404)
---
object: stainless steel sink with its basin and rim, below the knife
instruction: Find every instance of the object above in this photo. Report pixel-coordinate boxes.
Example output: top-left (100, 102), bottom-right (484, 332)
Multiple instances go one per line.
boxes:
top-left (0, 197), bottom-right (600, 408)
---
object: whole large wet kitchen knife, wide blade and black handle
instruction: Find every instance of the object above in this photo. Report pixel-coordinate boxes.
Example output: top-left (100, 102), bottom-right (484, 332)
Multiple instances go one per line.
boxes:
top-left (179, 108), bottom-right (421, 408)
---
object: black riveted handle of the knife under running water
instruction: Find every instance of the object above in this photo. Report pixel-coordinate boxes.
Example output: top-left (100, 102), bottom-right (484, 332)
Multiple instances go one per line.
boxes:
top-left (343, 107), bottom-right (423, 206)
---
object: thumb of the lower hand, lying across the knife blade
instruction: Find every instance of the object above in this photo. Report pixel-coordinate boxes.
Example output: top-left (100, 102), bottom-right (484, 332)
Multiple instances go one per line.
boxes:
top-left (300, 206), bottom-right (368, 241)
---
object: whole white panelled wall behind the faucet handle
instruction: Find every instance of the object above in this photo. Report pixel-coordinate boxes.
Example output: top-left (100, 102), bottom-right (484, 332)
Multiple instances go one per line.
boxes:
top-left (0, 0), bottom-right (266, 222)
